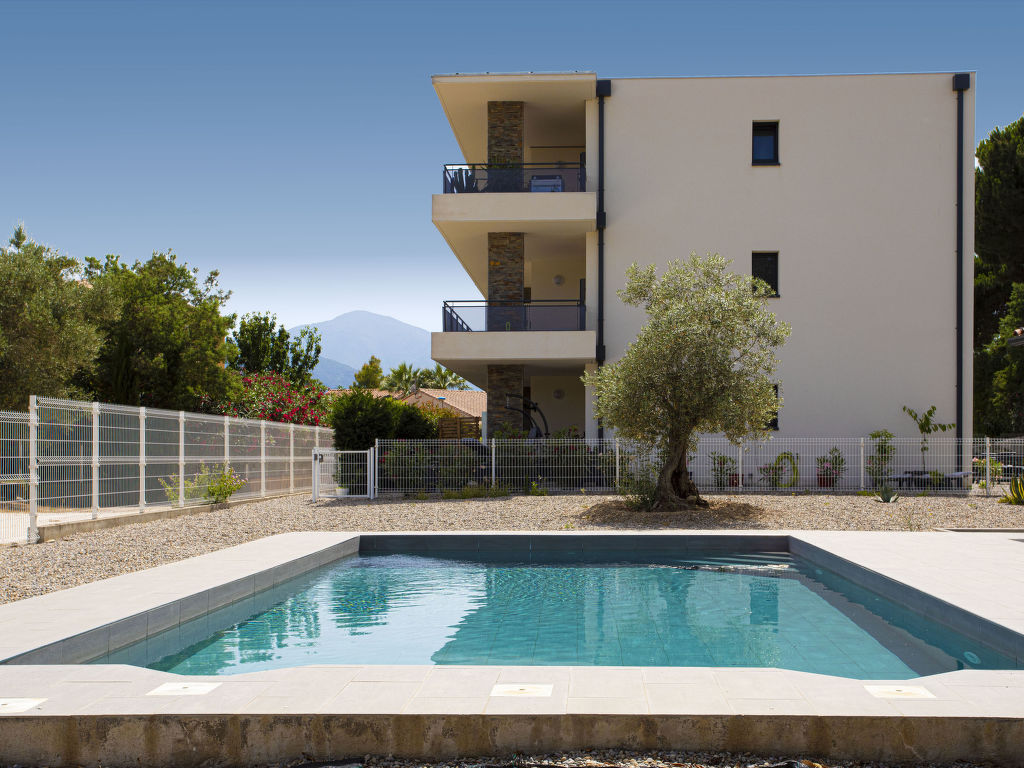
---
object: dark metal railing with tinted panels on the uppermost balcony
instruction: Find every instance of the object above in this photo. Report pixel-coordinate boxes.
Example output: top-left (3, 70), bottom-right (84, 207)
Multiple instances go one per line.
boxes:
top-left (444, 163), bottom-right (587, 195)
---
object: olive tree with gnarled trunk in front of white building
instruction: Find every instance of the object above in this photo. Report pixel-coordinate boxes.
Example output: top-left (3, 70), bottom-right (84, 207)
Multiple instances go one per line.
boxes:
top-left (584, 253), bottom-right (790, 507)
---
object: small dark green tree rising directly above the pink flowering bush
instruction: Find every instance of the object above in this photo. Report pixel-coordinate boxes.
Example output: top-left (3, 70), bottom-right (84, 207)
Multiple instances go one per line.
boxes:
top-left (230, 312), bottom-right (321, 384)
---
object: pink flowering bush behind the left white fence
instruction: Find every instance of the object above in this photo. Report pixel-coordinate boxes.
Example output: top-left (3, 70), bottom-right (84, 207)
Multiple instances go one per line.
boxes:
top-left (200, 374), bottom-right (328, 427)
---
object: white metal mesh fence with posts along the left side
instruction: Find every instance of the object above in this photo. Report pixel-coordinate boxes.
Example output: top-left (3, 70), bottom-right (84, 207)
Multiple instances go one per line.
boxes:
top-left (0, 397), bottom-right (332, 543)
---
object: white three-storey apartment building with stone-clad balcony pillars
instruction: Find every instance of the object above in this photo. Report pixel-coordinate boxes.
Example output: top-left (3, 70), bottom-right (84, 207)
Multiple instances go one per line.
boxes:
top-left (431, 73), bottom-right (975, 437)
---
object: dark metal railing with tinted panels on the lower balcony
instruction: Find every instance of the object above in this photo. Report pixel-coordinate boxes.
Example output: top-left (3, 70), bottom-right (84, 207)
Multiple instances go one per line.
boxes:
top-left (441, 300), bottom-right (587, 333)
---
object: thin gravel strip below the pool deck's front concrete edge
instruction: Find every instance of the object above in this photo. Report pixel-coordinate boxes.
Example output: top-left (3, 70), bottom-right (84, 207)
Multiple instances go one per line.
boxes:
top-left (272, 750), bottom-right (988, 768)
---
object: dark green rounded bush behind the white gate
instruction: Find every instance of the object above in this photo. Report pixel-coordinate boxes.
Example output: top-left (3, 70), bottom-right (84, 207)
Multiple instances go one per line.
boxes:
top-left (330, 389), bottom-right (440, 451)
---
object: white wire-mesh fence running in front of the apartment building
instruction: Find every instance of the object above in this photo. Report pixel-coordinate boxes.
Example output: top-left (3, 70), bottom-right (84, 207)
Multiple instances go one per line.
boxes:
top-left (358, 437), bottom-right (1024, 495)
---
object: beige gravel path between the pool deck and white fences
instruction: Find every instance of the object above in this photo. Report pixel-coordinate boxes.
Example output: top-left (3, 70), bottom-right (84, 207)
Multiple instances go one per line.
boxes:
top-left (0, 496), bottom-right (1024, 603)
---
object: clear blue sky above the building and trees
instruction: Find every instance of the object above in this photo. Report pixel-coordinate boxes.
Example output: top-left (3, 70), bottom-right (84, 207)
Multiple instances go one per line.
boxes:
top-left (0, 0), bottom-right (1024, 330)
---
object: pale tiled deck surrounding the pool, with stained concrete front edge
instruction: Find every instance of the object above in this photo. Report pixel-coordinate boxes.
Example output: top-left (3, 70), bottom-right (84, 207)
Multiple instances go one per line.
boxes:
top-left (0, 530), bottom-right (1024, 766)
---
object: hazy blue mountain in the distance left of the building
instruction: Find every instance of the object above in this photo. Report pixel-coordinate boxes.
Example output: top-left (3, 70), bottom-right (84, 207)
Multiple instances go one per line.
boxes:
top-left (289, 309), bottom-right (434, 384)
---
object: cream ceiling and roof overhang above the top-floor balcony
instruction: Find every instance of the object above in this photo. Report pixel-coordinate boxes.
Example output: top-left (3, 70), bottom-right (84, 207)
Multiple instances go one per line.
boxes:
top-left (432, 72), bottom-right (597, 163)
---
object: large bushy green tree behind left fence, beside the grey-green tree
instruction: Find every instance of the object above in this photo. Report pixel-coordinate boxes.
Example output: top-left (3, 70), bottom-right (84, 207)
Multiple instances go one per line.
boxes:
top-left (84, 252), bottom-right (234, 410)
